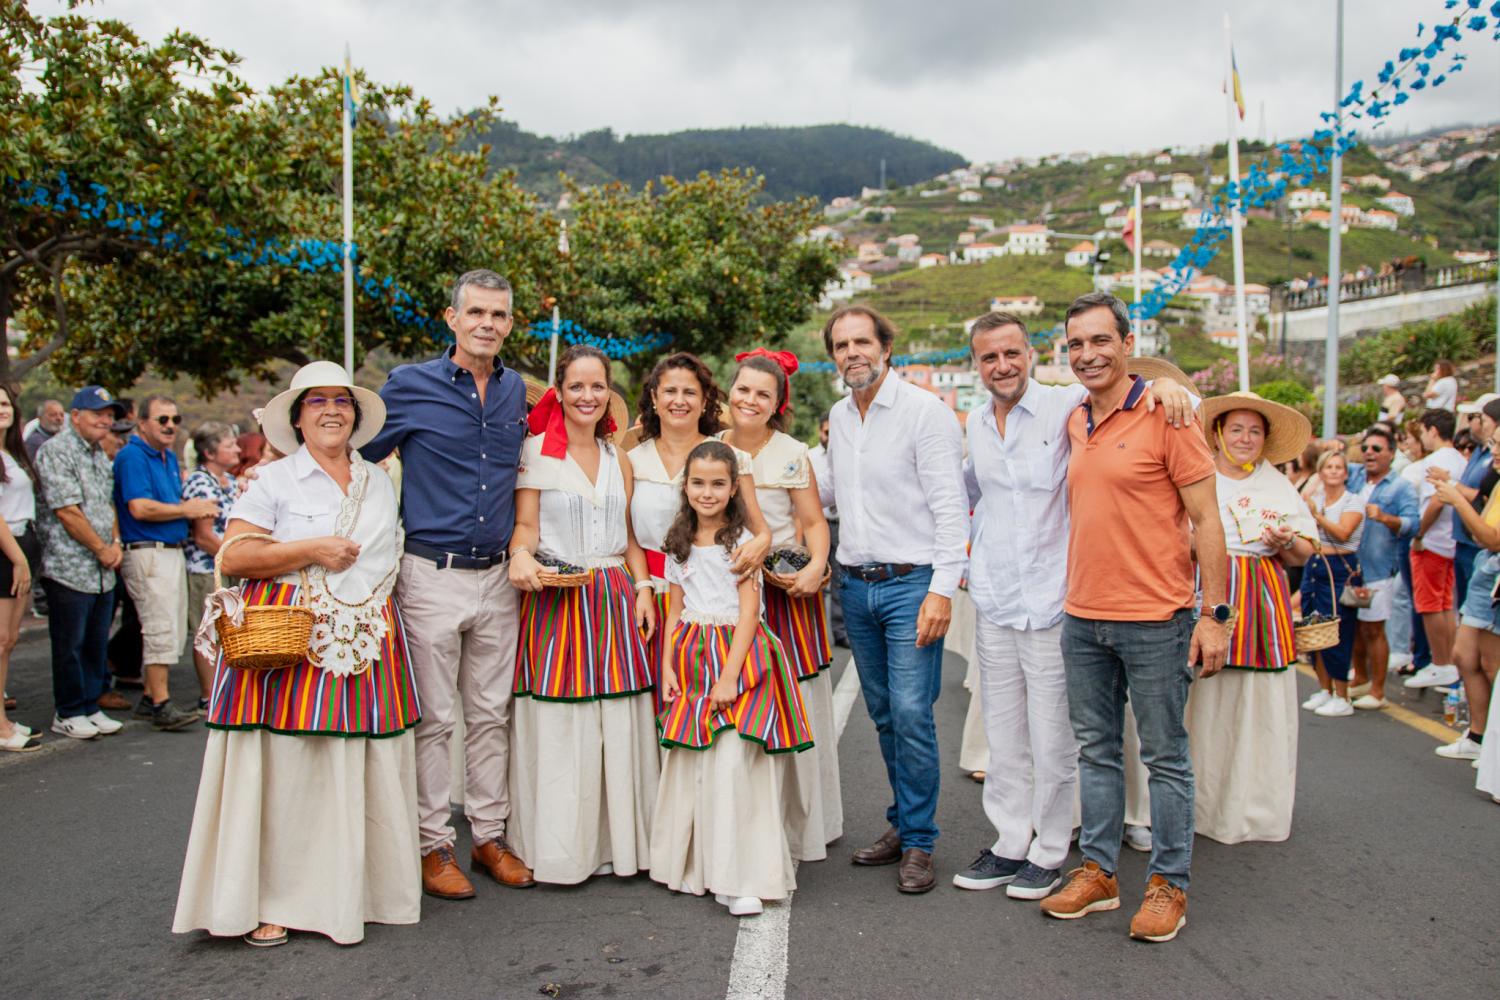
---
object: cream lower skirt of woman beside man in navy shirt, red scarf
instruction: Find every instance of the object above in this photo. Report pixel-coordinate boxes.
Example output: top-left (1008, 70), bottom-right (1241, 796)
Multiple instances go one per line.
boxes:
top-left (506, 691), bottom-right (659, 885)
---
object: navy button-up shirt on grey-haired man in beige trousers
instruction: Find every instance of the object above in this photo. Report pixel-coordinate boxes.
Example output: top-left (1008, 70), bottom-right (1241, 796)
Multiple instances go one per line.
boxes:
top-left (360, 348), bottom-right (527, 558)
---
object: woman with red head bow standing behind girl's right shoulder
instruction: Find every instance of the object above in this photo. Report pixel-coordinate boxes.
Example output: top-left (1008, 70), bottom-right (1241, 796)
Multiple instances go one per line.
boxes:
top-left (719, 348), bottom-right (843, 861)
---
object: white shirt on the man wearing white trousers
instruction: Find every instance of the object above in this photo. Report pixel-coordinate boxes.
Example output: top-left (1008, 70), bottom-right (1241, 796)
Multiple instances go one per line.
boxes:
top-left (963, 379), bottom-right (1088, 630)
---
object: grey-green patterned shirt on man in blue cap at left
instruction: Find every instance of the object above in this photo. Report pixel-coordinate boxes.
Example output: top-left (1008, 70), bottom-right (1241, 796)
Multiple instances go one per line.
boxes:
top-left (36, 424), bottom-right (117, 594)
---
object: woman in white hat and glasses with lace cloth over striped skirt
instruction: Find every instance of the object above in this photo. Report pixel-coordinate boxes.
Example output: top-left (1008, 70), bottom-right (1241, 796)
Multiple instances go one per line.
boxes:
top-left (173, 361), bottom-right (422, 948)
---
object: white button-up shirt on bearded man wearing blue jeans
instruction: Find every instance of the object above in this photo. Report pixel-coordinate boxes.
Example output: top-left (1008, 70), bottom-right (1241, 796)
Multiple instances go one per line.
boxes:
top-left (818, 372), bottom-right (969, 597)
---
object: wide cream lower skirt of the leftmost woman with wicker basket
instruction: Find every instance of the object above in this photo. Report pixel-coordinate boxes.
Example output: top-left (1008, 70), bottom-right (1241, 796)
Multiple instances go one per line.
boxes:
top-left (173, 729), bottom-right (422, 945)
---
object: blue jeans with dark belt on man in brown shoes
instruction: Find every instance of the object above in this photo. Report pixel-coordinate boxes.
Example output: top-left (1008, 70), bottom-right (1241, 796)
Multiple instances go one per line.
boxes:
top-left (839, 567), bottom-right (942, 852)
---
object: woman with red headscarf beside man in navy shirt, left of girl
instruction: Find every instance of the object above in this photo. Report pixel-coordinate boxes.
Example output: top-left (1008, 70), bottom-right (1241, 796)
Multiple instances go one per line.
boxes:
top-left (507, 345), bottom-right (659, 885)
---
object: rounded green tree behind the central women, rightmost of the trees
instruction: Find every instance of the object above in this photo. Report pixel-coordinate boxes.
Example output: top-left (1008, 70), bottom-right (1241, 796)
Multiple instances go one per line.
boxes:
top-left (558, 171), bottom-right (837, 373)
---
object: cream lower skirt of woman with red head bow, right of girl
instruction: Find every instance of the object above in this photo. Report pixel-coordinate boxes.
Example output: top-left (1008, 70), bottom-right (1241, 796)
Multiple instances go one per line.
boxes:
top-left (776, 670), bottom-right (843, 861)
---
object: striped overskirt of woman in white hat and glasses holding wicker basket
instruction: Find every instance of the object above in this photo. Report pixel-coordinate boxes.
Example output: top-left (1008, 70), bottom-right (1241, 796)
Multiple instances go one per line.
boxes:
top-left (204, 580), bottom-right (422, 738)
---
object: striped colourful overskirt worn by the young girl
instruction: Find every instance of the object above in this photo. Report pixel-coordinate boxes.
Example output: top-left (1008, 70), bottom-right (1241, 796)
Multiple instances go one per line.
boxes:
top-left (657, 622), bottom-right (813, 754)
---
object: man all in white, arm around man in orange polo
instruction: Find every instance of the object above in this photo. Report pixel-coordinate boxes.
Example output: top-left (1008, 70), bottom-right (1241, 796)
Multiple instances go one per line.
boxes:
top-left (953, 312), bottom-right (1194, 900)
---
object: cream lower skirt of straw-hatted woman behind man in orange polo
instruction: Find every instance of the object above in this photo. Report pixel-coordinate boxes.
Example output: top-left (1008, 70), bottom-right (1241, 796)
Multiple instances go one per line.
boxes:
top-left (1184, 670), bottom-right (1298, 844)
